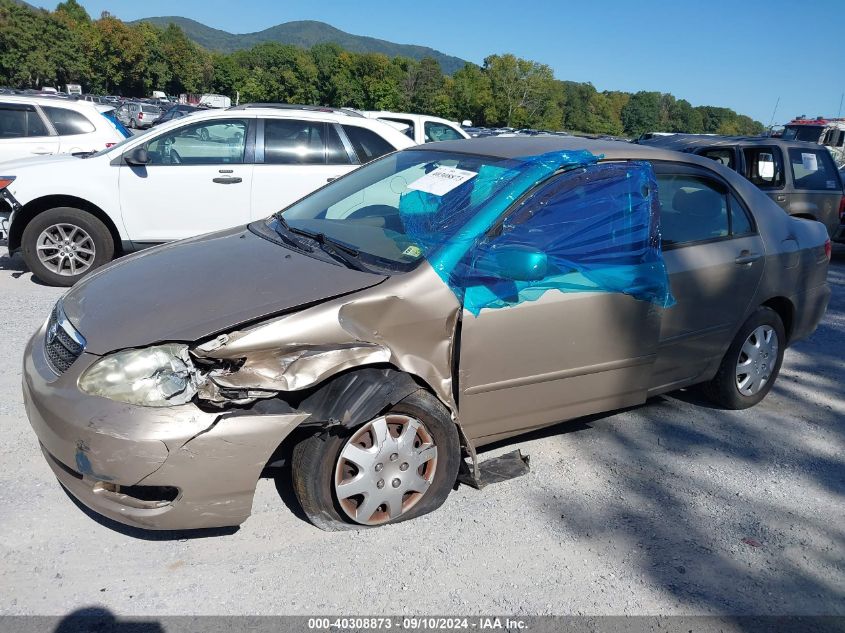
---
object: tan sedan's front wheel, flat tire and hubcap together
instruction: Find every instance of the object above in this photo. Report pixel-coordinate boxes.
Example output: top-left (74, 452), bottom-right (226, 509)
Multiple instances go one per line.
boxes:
top-left (291, 391), bottom-right (460, 530)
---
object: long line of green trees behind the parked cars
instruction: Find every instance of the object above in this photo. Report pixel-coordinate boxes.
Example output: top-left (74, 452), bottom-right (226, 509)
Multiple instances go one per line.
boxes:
top-left (0, 0), bottom-right (763, 136)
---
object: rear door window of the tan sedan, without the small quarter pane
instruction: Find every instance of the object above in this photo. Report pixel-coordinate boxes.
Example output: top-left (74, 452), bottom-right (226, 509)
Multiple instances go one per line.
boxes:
top-left (657, 174), bottom-right (729, 245)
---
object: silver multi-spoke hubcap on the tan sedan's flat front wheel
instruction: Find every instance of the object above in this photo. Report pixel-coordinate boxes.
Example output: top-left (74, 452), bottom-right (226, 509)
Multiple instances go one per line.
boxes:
top-left (334, 414), bottom-right (437, 525)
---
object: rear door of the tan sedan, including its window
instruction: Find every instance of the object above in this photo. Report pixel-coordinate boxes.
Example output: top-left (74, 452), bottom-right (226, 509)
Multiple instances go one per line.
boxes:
top-left (652, 163), bottom-right (765, 391)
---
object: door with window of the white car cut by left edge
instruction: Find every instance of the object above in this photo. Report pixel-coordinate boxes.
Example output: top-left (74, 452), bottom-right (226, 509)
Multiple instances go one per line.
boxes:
top-left (0, 102), bottom-right (59, 161)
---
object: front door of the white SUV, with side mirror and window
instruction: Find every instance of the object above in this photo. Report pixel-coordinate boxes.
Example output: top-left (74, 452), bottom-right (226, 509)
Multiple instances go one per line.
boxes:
top-left (120, 118), bottom-right (254, 245)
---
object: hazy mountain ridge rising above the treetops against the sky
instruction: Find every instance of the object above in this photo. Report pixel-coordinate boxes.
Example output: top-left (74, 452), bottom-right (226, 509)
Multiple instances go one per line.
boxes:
top-left (130, 15), bottom-right (466, 75)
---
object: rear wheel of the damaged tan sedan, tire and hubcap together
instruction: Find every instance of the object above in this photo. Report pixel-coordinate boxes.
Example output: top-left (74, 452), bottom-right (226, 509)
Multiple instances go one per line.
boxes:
top-left (702, 307), bottom-right (786, 409)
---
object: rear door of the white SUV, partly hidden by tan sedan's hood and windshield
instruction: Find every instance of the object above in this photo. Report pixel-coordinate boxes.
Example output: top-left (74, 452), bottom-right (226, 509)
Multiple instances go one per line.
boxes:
top-left (252, 117), bottom-right (357, 219)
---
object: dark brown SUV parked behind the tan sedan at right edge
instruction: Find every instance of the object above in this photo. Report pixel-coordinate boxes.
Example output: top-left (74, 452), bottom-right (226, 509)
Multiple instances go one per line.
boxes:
top-left (639, 134), bottom-right (845, 241)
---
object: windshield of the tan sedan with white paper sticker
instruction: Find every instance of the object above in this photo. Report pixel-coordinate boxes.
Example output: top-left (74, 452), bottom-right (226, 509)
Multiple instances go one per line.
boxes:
top-left (267, 150), bottom-right (536, 270)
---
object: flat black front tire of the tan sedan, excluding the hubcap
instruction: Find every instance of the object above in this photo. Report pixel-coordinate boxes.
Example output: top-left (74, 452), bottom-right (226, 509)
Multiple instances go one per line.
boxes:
top-left (291, 390), bottom-right (461, 531)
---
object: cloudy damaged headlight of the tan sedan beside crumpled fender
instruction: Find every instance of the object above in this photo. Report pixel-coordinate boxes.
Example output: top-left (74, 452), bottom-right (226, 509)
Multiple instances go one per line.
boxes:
top-left (79, 343), bottom-right (197, 407)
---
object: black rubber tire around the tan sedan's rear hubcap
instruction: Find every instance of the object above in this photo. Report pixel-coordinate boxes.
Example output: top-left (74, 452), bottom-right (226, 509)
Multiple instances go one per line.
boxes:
top-left (701, 306), bottom-right (786, 410)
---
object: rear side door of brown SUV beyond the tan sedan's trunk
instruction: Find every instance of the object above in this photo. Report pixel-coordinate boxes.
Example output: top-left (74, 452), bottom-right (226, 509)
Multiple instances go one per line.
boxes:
top-left (785, 146), bottom-right (843, 235)
